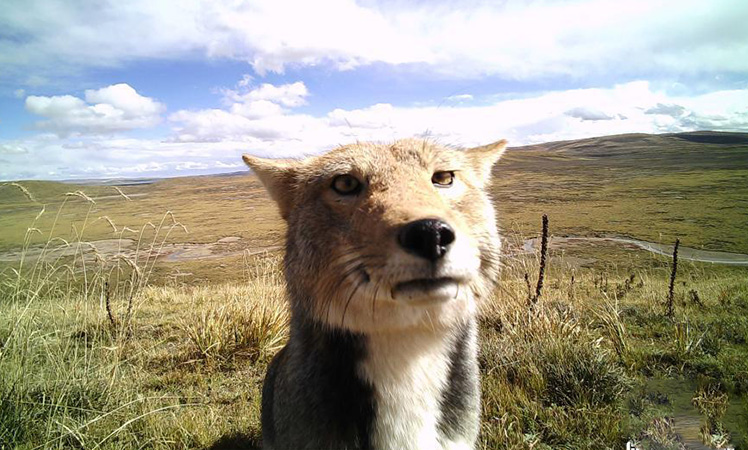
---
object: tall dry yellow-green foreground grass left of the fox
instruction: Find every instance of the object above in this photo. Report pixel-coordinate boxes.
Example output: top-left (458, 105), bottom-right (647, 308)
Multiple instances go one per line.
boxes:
top-left (0, 258), bottom-right (288, 449)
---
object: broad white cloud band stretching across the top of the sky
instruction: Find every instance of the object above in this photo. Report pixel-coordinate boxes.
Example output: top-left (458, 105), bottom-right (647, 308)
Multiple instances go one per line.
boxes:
top-left (0, 0), bottom-right (748, 83)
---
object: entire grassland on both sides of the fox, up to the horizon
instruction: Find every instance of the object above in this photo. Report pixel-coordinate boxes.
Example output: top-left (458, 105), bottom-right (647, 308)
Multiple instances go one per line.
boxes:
top-left (0, 134), bottom-right (748, 449)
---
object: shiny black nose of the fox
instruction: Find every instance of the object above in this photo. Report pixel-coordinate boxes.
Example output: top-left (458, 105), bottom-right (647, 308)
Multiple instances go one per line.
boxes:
top-left (397, 219), bottom-right (455, 261)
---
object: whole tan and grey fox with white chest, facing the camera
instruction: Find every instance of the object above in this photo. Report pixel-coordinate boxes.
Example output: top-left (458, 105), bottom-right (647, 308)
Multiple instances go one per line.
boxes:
top-left (244, 139), bottom-right (506, 450)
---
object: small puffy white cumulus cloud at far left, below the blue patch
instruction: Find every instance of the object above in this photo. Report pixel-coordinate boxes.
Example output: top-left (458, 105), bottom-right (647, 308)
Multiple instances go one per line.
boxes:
top-left (26, 84), bottom-right (165, 136)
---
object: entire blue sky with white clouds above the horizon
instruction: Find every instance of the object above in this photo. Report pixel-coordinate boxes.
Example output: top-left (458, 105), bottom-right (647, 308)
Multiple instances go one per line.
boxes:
top-left (0, 0), bottom-right (748, 180)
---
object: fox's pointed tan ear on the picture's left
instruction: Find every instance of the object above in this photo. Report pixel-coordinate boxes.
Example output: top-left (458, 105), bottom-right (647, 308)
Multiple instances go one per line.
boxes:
top-left (242, 154), bottom-right (299, 220)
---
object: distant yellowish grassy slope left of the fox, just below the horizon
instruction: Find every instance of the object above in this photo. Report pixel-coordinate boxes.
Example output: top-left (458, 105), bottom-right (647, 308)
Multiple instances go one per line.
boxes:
top-left (0, 176), bottom-right (283, 253)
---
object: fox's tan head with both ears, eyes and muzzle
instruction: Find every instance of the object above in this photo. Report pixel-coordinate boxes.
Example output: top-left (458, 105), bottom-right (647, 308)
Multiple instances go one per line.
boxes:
top-left (244, 139), bottom-right (506, 332)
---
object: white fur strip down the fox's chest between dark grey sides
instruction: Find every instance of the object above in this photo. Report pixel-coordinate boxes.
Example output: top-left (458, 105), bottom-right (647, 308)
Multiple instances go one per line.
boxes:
top-left (359, 330), bottom-right (472, 450)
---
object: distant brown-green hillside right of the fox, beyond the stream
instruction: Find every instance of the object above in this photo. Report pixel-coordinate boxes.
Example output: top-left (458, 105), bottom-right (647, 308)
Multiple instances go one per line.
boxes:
top-left (493, 133), bottom-right (748, 253)
